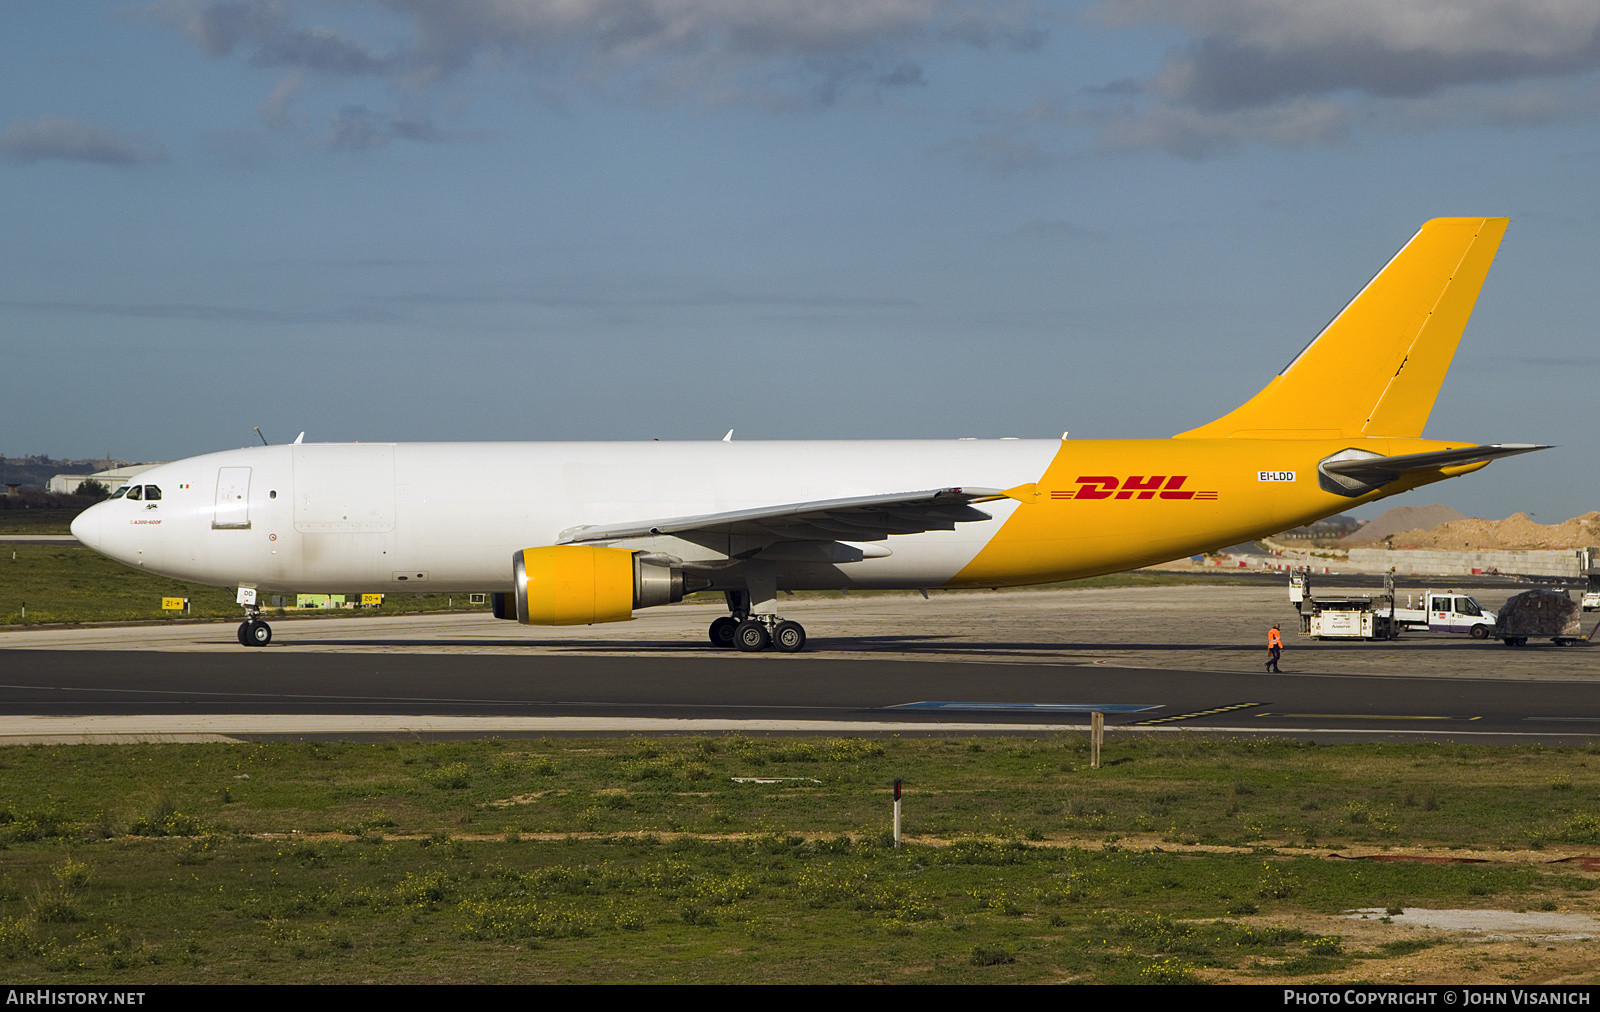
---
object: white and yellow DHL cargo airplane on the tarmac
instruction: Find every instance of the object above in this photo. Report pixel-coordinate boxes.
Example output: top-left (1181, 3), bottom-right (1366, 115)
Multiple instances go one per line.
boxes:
top-left (72, 218), bottom-right (1542, 652)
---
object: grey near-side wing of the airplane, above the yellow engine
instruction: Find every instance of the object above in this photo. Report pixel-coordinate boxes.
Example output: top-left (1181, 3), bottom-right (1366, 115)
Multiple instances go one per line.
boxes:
top-left (557, 488), bottom-right (1008, 544)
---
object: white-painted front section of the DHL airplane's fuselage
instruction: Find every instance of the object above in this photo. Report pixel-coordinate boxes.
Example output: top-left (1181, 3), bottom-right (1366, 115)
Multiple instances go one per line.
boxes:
top-left (72, 439), bottom-right (1061, 592)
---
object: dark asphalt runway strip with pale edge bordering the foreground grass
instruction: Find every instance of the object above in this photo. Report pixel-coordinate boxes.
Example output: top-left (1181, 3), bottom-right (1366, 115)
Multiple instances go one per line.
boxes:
top-left (0, 650), bottom-right (1600, 743)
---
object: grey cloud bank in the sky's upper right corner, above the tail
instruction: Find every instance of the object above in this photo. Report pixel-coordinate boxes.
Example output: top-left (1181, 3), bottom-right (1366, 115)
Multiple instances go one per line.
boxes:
top-left (1093, 0), bottom-right (1600, 157)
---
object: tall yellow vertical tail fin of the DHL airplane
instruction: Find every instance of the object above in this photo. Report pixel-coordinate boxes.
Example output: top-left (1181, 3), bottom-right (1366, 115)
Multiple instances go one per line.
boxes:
top-left (1178, 218), bottom-right (1507, 439)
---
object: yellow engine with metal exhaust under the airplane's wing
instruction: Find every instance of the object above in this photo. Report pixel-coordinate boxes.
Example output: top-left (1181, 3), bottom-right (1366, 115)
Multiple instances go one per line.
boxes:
top-left (508, 544), bottom-right (691, 626)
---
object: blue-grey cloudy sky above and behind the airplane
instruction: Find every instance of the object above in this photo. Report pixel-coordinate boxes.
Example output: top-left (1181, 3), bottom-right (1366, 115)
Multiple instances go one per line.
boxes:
top-left (0, 0), bottom-right (1600, 522)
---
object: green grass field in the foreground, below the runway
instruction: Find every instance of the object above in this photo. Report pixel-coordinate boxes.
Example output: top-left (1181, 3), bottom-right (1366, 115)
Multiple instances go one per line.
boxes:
top-left (0, 735), bottom-right (1600, 983)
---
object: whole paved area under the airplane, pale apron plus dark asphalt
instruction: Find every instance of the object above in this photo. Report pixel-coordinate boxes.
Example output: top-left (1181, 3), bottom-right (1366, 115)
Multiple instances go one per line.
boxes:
top-left (0, 586), bottom-right (1600, 743)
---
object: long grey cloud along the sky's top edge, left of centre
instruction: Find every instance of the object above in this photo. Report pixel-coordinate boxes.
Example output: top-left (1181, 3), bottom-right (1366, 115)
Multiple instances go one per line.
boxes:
top-left (141, 0), bottom-right (1045, 104)
